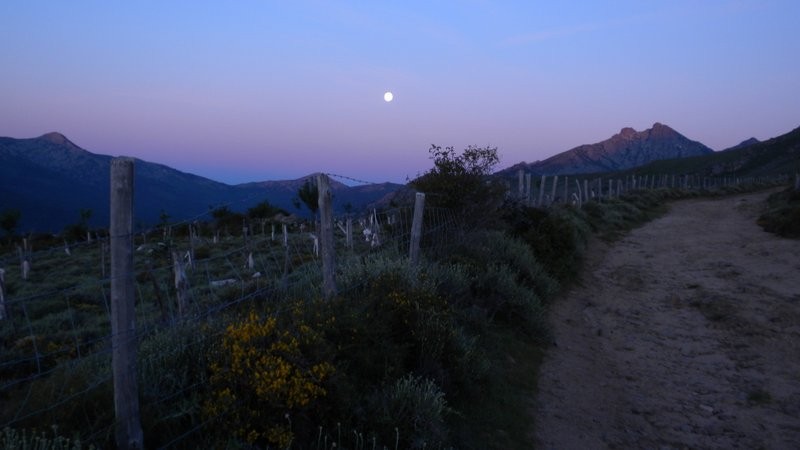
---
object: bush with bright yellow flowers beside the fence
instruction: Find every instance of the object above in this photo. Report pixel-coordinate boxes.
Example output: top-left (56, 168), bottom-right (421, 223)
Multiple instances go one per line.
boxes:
top-left (204, 312), bottom-right (334, 448)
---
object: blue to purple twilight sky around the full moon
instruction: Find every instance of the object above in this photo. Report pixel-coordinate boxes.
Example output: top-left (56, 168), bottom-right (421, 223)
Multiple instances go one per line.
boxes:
top-left (0, 0), bottom-right (800, 184)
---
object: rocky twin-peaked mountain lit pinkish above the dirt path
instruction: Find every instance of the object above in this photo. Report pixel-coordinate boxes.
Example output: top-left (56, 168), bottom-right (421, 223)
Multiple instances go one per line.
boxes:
top-left (504, 122), bottom-right (713, 175)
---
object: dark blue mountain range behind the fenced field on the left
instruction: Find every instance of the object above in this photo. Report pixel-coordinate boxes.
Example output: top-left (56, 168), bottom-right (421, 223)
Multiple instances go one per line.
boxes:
top-left (0, 133), bottom-right (400, 232)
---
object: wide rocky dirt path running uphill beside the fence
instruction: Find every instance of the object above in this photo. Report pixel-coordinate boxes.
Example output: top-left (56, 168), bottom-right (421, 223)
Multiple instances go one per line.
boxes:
top-left (534, 193), bottom-right (800, 450)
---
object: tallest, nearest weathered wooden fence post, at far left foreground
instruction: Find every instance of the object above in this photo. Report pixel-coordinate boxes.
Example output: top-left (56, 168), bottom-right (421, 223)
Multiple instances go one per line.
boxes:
top-left (110, 158), bottom-right (144, 449)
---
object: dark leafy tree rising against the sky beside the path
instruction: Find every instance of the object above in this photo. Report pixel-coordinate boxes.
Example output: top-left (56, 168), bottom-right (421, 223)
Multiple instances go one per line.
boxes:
top-left (409, 145), bottom-right (505, 219)
